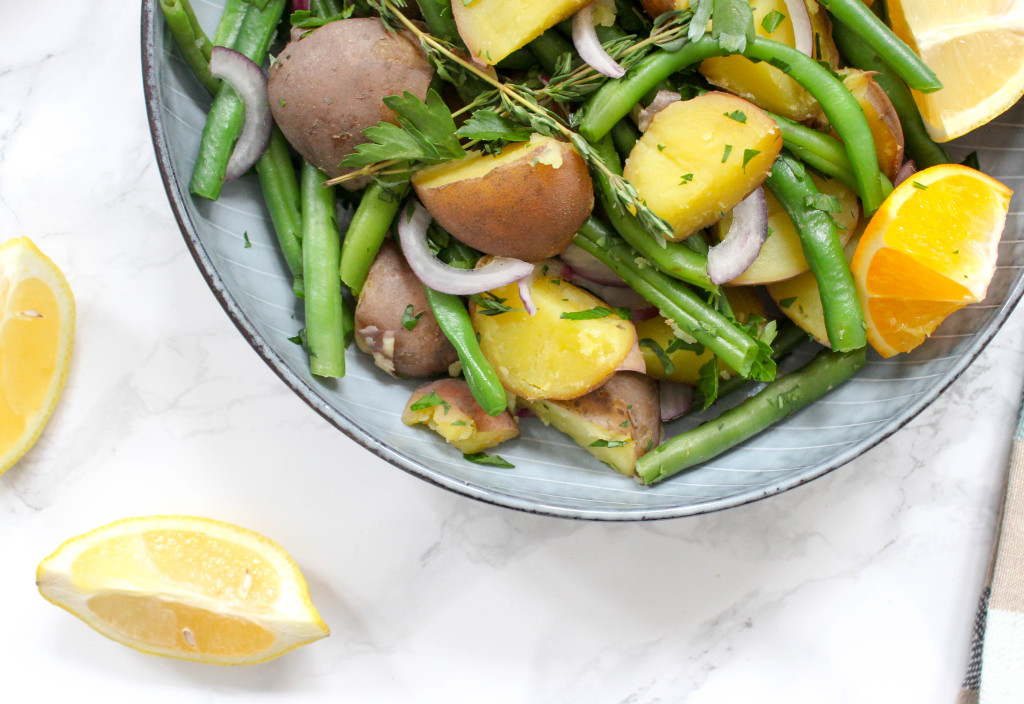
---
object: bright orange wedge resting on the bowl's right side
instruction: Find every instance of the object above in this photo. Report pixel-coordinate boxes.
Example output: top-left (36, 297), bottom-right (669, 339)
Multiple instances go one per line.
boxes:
top-left (851, 164), bottom-right (1013, 357)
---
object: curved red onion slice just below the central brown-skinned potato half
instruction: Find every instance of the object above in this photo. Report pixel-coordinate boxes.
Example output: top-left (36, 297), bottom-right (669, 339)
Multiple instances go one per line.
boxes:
top-left (398, 201), bottom-right (534, 296)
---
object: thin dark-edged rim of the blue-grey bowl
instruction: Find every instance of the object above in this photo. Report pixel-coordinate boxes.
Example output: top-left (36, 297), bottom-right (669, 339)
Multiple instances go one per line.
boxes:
top-left (141, 0), bottom-right (1024, 522)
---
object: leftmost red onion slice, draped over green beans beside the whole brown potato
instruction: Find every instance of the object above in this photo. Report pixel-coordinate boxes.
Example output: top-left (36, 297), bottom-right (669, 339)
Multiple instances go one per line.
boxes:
top-left (210, 46), bottom-right (273, 181)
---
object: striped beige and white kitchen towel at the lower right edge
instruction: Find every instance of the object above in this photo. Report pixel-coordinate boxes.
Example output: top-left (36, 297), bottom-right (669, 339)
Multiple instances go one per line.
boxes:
top-left (957, 392), bottom-right (1024, 704)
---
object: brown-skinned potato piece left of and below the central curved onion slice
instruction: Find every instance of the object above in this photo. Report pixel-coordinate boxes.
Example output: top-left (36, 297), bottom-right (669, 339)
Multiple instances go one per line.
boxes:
top-left (355, 240), bottom-right (459, 379)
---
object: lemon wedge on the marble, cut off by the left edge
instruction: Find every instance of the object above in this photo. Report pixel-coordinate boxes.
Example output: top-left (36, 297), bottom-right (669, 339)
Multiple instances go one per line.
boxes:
top-left (0, 237), bottom-right (75, 474)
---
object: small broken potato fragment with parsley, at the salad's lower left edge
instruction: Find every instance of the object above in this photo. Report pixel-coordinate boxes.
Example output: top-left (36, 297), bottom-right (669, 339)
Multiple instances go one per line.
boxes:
top-left (401, 379), bottom-right (519, 453)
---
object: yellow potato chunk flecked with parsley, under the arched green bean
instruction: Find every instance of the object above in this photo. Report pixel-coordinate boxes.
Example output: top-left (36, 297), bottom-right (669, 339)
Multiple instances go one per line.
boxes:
top-left (624, 92), bottom-right (782, 239)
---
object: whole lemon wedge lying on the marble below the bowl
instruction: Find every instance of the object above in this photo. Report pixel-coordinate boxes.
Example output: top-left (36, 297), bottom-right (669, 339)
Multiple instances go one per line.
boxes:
top-left (36, 516), bottom-right (330, 665)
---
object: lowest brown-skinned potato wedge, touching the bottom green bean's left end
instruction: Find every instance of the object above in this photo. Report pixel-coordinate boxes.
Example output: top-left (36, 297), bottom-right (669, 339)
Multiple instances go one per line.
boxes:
top-left (522, 371), bottom-right (662, 477)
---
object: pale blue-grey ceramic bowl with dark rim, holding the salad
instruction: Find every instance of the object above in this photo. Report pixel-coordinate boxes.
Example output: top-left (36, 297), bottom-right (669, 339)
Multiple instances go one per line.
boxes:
top-left (142, 0), bottom-right (1024, 521)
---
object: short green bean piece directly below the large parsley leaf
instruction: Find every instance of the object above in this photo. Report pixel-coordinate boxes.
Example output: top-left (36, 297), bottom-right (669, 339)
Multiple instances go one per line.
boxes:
top-left (339, 181), bottom-right (409, 296)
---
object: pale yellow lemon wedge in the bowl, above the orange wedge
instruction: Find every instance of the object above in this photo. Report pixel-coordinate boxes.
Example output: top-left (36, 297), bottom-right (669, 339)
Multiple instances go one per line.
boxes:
top-left (888, 0), bottom-right (1024, 142)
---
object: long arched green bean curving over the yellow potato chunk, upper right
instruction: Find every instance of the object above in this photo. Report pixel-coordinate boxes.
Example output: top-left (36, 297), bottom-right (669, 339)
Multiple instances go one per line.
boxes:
top-left (580, 37), bottom-right (884, 214)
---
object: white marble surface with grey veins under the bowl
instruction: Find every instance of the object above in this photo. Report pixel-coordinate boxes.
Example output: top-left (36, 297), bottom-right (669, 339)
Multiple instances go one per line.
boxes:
top-left (0, 0), bottom-right (1024, 704)
